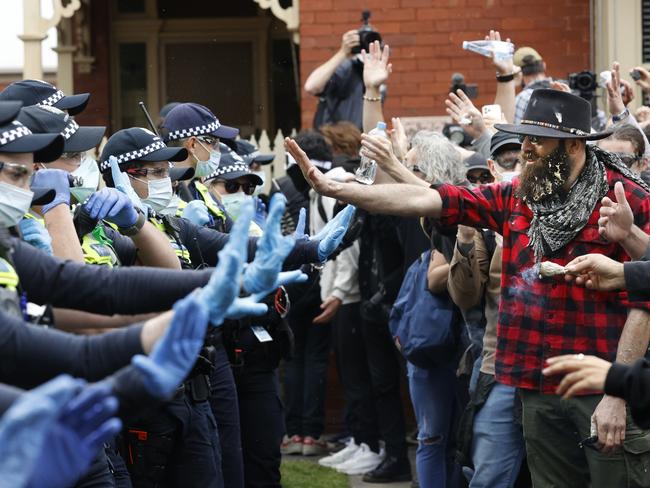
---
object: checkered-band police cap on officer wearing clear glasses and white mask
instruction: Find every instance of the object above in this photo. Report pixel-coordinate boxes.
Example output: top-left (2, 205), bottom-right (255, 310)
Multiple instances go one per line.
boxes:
top-left (99, 127), bottom-right (187, 173)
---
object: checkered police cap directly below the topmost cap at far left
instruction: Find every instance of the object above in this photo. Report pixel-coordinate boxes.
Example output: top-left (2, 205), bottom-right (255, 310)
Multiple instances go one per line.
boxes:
top-left (18, 105), bottom-right (106, 152)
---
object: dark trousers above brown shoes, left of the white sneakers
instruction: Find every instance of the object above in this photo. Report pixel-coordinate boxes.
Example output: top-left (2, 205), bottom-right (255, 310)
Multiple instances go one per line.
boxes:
top-left (284, 304), bottom-right (331, 438)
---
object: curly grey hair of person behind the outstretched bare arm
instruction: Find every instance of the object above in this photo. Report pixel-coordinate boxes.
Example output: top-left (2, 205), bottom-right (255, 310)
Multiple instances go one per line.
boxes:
top-left (411, 130), bottom-right (466, 185)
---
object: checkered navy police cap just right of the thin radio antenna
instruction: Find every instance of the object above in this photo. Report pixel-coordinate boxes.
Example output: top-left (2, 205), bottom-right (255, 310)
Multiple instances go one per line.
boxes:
top-left (163, 103), bottom-right (239, 141)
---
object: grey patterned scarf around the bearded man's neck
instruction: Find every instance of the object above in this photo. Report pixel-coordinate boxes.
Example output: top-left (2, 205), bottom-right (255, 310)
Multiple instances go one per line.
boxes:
top-left (526, 146), bottom-right (650, 262)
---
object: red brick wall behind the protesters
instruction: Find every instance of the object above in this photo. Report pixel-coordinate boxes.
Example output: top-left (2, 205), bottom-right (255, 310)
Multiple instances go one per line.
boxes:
top-left (300, 0), bottom-right (590, 127)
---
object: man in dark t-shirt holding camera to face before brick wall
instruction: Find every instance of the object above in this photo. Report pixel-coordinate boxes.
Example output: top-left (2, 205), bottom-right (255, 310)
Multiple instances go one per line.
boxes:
top-left (305, 10), bottom-right (383, 129)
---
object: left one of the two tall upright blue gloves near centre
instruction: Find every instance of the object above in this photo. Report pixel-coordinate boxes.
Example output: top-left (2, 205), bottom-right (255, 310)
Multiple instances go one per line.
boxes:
top-left (199, 198), bottom-right (268, 326)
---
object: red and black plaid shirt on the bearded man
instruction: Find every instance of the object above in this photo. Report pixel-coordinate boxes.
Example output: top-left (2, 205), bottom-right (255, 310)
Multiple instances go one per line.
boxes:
top-left (436, 169), bottom-right (650, 393)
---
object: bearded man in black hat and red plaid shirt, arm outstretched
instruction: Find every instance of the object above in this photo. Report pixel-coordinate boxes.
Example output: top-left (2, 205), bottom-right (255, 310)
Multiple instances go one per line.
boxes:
top-left (286, 89), bottom-right (650, 488)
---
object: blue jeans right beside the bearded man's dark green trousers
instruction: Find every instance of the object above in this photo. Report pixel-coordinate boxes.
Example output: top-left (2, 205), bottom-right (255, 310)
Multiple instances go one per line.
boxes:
top-left (469, 383), bottom-right (526, 488)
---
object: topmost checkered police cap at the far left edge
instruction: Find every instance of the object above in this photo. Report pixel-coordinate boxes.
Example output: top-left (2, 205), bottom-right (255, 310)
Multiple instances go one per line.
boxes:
top-left (0, 80), bottom-right (90, 115)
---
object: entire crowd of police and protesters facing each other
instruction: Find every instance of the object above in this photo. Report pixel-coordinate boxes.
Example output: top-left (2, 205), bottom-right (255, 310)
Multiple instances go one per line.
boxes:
top-left (0, 17), bottom-right (650, 488)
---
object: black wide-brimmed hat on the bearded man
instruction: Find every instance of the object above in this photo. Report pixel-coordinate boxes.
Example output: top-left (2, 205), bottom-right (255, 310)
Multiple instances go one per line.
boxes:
top-left (494, 88), bottom-right (612, 141)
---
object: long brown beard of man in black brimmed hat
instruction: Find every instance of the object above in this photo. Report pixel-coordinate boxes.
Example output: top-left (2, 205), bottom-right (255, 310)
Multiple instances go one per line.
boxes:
top-left (515, 142), bottom-right (571, 202)
